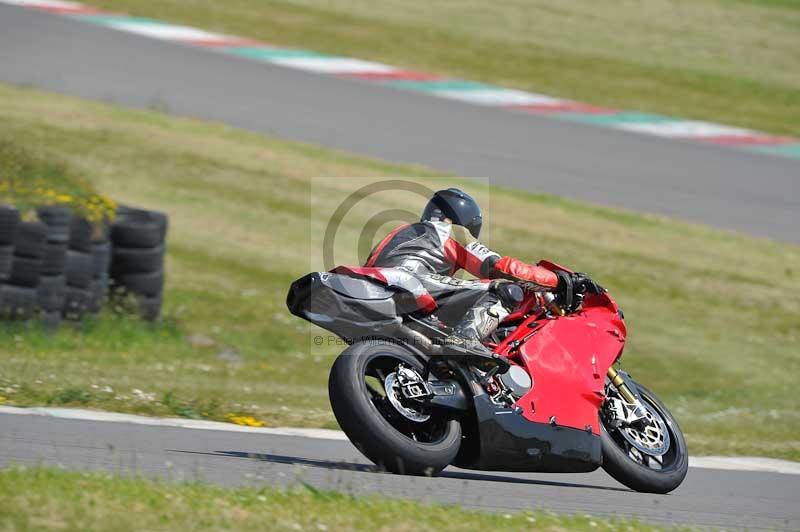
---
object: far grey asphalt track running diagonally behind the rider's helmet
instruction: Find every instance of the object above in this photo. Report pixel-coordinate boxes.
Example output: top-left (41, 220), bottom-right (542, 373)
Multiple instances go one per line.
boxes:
top-left (0, 5), bottom-right (800, 243)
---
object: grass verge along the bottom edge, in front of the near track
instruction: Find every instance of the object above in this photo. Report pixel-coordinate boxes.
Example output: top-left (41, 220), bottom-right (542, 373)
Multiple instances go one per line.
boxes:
top-left (0, 469), bottom-right (675, 532)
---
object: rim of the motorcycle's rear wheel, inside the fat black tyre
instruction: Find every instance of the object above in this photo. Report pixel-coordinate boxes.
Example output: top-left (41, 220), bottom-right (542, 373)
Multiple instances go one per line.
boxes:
top-left (361, 354), bottom-right (449, 444)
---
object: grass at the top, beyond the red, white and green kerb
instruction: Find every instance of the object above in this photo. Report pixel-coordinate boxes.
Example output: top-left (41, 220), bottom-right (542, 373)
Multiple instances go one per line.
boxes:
top-left (87, 0), bottom-right (800, 135)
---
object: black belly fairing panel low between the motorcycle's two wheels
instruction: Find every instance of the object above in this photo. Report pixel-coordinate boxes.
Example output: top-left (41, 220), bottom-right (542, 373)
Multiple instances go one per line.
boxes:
top-left (456, 394), bottom-right (602, 473)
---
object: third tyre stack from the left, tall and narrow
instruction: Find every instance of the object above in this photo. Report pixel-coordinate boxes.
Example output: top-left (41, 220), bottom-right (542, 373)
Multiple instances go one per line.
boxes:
top-left (36, 206), bottom-right (73, 331)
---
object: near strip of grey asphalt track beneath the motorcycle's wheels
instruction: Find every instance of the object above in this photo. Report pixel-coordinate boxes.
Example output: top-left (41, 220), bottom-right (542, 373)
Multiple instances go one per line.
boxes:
top-left (0, 414), bottom-right (800, 530)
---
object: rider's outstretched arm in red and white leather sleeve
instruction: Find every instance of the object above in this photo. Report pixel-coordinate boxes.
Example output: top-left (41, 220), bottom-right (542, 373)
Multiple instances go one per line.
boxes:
top-left (445, 238), bottom-right (558, 290)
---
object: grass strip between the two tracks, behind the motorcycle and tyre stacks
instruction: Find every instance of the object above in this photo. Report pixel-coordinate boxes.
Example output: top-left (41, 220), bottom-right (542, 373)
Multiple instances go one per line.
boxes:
top-left (0, 85), bottom-right (800, 460)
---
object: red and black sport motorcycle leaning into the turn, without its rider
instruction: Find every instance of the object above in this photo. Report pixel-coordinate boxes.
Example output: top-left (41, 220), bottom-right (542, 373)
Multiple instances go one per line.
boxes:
top-left (287, 261), bottom-right (688, 493)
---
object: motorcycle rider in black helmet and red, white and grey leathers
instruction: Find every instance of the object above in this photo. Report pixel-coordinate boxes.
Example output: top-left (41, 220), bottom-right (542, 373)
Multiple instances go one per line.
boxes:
top-left (365, 188), bottom-right (599, 354)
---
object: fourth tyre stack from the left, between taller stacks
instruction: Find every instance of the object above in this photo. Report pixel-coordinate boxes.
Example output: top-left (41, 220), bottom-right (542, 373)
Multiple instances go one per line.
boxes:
top-left (62, 217), bottom-right (94, 321)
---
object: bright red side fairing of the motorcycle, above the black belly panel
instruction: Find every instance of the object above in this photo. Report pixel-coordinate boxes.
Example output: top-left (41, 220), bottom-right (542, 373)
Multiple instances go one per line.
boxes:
top-left (495, 294), bottom-right (626, 434)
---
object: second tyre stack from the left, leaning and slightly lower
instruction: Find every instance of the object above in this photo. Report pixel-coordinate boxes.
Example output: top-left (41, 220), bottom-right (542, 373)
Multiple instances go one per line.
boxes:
top-left (0, 222), bottom-right (47, 319)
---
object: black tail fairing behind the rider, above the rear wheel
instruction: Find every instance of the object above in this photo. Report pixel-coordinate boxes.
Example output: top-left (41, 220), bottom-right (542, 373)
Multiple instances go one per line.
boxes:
top-left (286, 272), bottom-right (401, 340)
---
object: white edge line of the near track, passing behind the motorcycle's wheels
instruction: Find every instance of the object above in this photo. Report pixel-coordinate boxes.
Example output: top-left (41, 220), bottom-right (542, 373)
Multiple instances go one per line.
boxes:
top-left (0, 406), bottom-right (800, 475)
